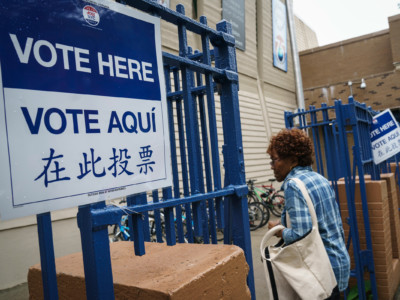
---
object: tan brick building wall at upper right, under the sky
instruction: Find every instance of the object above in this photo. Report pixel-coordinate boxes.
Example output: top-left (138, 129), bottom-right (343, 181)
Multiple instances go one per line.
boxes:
top-left (300, 15), bottom-right (400, 110)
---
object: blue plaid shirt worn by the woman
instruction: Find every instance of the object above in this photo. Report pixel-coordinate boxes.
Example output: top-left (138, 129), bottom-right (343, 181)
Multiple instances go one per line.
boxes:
top-left (281, 167), bottom-right (350, 291)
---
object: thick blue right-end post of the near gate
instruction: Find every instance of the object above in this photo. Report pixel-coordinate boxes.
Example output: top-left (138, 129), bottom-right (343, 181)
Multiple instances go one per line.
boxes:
top-left (215, 21), bottom-right (255, 299)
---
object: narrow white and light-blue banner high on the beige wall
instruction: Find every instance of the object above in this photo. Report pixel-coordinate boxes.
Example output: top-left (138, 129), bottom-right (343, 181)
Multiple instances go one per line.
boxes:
top-left (272, 0), bottom-right (287, 72)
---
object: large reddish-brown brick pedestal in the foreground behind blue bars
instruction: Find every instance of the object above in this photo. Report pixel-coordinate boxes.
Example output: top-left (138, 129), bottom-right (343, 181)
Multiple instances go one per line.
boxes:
top-left (28, 242), bottom-right (251, 300)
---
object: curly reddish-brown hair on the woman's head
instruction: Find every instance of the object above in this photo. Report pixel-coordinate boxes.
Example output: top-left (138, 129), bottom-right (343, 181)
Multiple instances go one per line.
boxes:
top-left (267, 128), bottom-right (313, 167)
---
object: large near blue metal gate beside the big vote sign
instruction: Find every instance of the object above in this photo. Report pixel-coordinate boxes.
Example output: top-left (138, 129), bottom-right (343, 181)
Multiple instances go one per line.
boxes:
top-left (33, 0), bottom-right (255, 299)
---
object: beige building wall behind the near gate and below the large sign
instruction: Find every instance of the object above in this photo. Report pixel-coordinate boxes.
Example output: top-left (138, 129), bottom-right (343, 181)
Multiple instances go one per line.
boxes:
top-left (0, 0), bottom-right (297, 290)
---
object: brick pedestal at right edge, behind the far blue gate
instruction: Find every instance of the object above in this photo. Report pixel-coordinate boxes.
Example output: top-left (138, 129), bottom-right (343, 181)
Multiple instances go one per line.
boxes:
top-left (338, 174), bottom-right (400, 299)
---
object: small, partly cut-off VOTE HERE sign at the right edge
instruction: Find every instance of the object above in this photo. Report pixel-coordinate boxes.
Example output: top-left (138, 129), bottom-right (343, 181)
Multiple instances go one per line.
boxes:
top-left (370, 109), bottom-right (400, 164)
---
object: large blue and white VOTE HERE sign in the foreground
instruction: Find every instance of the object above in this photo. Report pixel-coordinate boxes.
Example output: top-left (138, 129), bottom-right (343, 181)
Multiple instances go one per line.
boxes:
top-left (0, 0), bottom-right (172, 219)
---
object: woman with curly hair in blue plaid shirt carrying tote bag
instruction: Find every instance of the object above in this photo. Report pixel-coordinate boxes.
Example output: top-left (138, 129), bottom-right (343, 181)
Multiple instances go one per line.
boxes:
top-left (267, 129), bottom-right (350, 299)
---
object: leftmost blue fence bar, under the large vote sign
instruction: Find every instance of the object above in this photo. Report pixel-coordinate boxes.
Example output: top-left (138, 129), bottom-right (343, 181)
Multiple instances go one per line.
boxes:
top-left (36, 212), bottom-right (58, 300)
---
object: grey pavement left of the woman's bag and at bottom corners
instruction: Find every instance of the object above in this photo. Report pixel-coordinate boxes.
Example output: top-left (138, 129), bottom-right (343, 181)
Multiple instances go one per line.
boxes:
top-left (0, 216), bottom-right (400, 300)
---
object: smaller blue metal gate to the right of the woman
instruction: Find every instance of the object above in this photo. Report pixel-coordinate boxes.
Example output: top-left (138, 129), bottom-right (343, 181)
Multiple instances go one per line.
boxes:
top-left (285, 97), bottom-right (385, 299)
